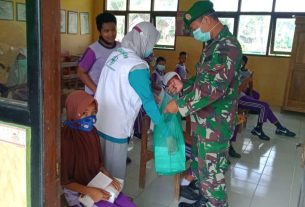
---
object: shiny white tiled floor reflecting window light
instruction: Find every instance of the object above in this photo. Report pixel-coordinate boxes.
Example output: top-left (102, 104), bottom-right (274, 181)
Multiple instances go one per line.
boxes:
top-left (124, 109), bottom-right (305, 207)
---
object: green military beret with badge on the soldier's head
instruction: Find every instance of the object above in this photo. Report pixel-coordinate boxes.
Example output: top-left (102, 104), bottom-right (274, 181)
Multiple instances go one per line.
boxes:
top-left (183, 0), bottom-right (215, 28)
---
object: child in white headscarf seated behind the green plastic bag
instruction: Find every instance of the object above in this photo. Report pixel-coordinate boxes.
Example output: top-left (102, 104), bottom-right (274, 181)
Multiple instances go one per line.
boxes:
top-left (159, 72), bottom-right (199, 200)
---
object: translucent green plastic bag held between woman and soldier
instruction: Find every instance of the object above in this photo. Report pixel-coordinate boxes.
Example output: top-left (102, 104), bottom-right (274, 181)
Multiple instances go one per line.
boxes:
top-left (153, 93), bottom-right (185, 175)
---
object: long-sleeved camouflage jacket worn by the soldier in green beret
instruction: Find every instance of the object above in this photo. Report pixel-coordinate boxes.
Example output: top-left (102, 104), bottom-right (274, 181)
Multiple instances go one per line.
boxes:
top-left (177, 26), bottom-right (242, 150)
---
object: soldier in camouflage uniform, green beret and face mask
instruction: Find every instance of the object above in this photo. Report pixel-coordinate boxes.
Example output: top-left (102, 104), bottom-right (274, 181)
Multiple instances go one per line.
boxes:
top-left (165, 1), bottom-right (242, 207)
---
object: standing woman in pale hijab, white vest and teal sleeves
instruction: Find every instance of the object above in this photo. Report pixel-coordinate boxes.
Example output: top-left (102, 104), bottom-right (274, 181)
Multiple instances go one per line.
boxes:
top-left (95, 22), bottom-right (166, 179)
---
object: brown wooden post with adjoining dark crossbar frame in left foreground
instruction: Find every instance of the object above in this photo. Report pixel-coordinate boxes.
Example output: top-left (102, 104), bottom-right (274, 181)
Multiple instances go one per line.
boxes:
top-left (0, 0), bottom-right (61, 207)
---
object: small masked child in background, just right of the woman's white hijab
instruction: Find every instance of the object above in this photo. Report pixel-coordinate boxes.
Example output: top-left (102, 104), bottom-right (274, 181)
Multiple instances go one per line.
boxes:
top-left (151, 56), bottom-right (166, 95)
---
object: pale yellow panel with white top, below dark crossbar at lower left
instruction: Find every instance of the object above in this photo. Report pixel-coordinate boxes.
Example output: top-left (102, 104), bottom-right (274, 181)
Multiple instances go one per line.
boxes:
top-left (0, 122), bottom-right (31, 207)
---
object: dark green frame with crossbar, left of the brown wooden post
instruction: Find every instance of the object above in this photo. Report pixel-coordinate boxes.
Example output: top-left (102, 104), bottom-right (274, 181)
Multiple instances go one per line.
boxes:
top-left (0, 0), bottom-right (44, 206)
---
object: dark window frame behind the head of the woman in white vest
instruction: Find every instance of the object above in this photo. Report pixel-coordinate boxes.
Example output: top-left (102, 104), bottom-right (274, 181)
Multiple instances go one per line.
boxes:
top-left (104, 0), bottom-right (179, 51)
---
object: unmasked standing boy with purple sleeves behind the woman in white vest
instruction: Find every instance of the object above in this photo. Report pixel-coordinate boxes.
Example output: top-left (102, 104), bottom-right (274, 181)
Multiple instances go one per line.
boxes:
top-left (77, 12), bottom-right (120, 95)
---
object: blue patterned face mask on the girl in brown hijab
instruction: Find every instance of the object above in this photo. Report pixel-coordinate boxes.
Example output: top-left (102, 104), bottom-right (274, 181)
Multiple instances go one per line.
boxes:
top-left (64, 115), bottom-right (96, 132)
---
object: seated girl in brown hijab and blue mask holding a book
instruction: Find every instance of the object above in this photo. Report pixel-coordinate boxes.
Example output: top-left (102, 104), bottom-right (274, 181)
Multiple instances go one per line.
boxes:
top-left (61, 91), bottom-right (136, 207)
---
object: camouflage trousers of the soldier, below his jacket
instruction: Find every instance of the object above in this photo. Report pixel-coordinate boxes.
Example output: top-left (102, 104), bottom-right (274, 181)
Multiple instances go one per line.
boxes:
top-left (191, 135), bottom-right (229, 207)
